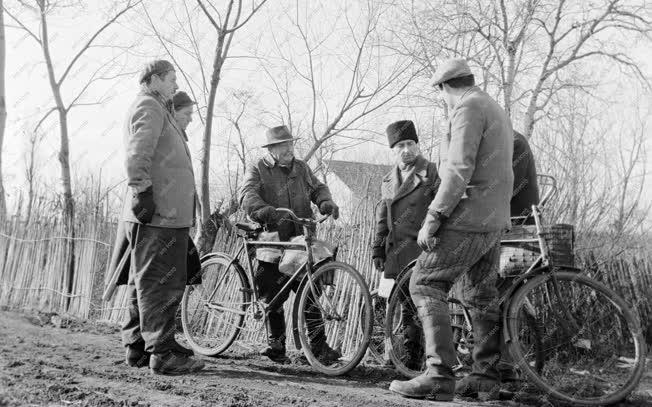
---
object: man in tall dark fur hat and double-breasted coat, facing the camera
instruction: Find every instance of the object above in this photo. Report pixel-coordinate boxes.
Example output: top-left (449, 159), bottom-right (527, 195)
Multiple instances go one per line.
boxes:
top-left (372, 120), bottom-right (439, 370)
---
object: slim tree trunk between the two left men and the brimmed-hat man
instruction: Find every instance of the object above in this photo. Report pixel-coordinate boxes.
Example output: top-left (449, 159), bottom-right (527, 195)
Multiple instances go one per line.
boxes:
top-left (195, 37), bottom-right (225, 255)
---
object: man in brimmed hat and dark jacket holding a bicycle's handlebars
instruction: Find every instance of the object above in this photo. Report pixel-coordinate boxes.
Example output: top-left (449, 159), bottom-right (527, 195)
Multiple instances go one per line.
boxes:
top-left (239, 126), bottom-right (339, 363)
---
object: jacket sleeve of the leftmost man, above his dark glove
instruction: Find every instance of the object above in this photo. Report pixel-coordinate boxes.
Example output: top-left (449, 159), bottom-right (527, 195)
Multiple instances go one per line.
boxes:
top-left (126, 98), bottom-right (165, 192)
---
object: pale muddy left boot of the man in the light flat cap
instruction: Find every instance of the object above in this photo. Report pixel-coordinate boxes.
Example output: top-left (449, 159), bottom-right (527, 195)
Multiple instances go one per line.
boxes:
top-left (389, 308), bottom-right (455, 401)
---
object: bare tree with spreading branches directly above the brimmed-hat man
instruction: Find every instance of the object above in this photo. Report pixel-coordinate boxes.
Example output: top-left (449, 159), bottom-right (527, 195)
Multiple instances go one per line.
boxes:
top-left (263, 1), bottom-right (424, 167)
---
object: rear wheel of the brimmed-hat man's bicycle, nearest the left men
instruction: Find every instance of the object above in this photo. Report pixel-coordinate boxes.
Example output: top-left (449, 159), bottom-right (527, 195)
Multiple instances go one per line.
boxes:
top-left (181, 254), bottom-right (250, 356)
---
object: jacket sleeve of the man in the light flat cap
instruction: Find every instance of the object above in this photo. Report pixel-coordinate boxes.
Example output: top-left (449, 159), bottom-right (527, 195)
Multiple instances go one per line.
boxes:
top-left (428, 101), bottom-right (484, 216)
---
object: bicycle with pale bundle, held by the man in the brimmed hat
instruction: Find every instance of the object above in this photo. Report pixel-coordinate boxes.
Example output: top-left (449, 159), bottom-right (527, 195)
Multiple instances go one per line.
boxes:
top-left (181, 208), bottom-right (372, 376)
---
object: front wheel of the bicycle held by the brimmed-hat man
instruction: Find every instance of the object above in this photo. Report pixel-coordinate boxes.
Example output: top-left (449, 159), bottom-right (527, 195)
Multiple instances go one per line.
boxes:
top-left (298, 261), bottom-right (373, 376)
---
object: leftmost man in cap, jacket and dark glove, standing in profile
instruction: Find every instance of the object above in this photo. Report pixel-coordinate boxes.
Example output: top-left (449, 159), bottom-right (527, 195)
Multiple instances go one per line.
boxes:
top-left (115, 60), bottom-right (204, 375)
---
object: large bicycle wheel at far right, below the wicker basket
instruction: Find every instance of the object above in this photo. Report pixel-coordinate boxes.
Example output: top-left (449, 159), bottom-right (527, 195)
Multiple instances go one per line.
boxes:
top-left (507, 270), bottom-right (646, 405)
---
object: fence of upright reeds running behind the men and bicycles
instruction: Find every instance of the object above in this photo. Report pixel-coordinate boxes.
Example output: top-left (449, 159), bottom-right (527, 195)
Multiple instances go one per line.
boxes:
top-left (0, 201), bottom-right (652, 346)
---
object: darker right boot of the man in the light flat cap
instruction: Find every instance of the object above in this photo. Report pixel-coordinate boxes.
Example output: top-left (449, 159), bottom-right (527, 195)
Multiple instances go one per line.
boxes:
top-left (455, 311), bottom-right (501, 401)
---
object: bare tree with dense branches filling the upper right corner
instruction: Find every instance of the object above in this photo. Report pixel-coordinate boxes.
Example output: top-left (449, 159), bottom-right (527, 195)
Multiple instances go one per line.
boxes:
top-left (403, 0), bottom-right (652, 138)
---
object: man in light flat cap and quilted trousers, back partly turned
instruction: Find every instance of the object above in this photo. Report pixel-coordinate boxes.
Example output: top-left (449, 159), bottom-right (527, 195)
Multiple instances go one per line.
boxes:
top-left (390, 59), bottom-right (514, 401)
